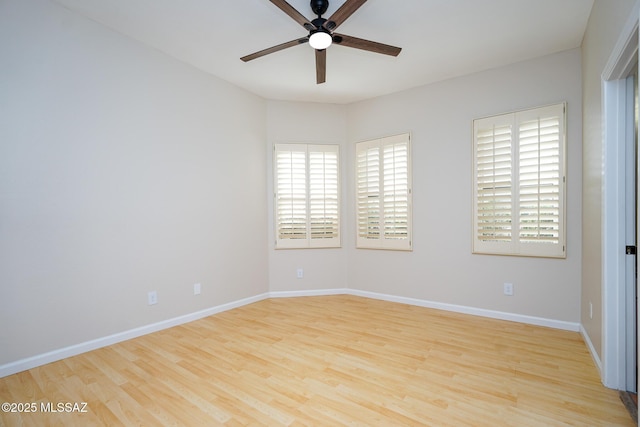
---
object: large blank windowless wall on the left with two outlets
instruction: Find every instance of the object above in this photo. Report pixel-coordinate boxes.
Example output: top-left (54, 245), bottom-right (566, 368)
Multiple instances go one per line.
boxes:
top-left (0, 0), bottom-right (268, 366)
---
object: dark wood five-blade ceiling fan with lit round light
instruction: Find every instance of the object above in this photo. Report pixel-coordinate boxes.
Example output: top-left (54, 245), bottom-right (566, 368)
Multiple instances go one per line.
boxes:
top-left (240, 0), bottom-right (402, 84)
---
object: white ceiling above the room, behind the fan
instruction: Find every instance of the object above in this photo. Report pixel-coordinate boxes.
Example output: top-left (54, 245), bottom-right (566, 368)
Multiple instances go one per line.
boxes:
top-left (55, 0), bottom-right (593, 104)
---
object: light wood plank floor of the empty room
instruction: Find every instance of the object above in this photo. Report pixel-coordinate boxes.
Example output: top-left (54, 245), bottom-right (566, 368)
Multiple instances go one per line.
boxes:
top-left (0, 296), bottom-right (634, 427)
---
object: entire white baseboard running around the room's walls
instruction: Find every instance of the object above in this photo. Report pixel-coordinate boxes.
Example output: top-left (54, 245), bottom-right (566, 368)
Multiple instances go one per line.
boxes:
top-left (0, 288), bottom-right (580, 378)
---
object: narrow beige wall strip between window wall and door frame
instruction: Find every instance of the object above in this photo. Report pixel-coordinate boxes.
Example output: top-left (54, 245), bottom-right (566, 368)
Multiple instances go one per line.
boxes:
top-left (580, 0), bottom-right (635, 358)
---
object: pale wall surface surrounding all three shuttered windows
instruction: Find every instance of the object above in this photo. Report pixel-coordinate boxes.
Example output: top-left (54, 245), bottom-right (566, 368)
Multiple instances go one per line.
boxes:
top-left (267, 49), bottom-right (582, 324)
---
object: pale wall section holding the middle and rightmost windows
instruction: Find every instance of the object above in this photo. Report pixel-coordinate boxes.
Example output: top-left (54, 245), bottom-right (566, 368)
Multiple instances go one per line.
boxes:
top-left (346, 49), bottom-right (582, 323)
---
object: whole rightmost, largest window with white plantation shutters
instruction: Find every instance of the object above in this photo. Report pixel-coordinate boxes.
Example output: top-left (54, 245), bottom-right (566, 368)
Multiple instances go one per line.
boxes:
top-left (473, 103), bottom-right (566, 258)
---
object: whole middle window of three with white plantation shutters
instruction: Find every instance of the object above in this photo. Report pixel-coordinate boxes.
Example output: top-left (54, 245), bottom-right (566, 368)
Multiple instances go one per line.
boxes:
top-left (356, 134), bottom-right (412, 251)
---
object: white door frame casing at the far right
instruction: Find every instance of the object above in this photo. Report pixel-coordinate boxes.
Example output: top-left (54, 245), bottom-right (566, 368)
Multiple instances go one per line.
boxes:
top-left (601, 2), bottom-right (640, 390)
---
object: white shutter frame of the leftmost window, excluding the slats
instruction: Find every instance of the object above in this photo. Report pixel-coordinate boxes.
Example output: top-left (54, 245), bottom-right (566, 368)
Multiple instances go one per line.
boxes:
top-left (273, 143), bottom-right (341, 249)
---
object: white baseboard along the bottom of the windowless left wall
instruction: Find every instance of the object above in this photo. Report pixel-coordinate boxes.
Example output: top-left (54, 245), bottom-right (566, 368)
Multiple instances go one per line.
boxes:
top-left (0, 293), bottom-right (269, 378)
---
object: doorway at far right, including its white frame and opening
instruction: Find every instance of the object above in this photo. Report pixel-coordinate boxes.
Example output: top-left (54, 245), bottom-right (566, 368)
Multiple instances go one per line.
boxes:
top-left (601, 10), bottom-right (640, 398)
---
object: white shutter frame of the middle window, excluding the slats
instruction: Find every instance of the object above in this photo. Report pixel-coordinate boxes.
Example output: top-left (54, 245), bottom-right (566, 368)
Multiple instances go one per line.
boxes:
top-left (355, 133), bottom-right (413, 251)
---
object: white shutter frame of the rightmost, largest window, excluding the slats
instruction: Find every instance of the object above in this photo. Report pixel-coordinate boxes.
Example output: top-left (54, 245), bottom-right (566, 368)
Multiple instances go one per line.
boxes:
top-left (472, 102), bottom-right (567, 258)
